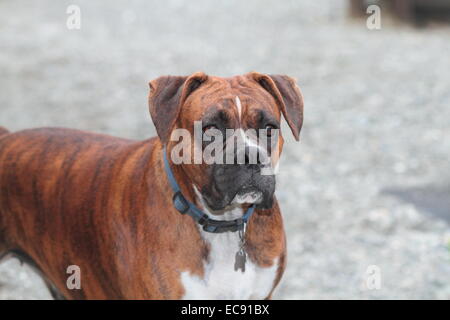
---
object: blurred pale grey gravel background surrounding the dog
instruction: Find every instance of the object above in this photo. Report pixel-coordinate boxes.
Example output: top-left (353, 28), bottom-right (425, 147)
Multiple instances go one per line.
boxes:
top-left (0, 0), bottom-right (450, 299)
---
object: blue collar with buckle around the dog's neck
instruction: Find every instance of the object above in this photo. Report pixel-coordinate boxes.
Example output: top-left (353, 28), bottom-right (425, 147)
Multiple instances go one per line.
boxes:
top-left (163, 146), bottom-right (255, 233)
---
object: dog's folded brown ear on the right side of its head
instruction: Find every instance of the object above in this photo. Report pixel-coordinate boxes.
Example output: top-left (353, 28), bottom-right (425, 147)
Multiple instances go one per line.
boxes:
top-left (251, 72), bottom-right (303, 141)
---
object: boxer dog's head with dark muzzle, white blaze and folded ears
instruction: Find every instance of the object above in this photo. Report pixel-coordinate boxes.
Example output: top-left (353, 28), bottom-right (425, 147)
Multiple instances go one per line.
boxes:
top-left (149, 72), bottom-right (303, 211)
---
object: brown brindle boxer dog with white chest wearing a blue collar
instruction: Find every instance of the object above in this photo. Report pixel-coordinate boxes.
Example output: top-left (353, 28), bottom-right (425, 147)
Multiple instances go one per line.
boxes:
top-left (0, 72), bottom-right (303, 299)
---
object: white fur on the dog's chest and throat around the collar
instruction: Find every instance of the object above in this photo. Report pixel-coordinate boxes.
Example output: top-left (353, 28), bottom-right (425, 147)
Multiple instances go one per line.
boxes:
top-left (181, 188), bottom-right (278, 299)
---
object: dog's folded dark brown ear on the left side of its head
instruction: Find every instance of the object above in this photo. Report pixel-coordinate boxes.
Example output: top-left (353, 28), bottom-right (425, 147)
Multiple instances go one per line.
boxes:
top-left (148, 72), bottom-right (208, 143)
